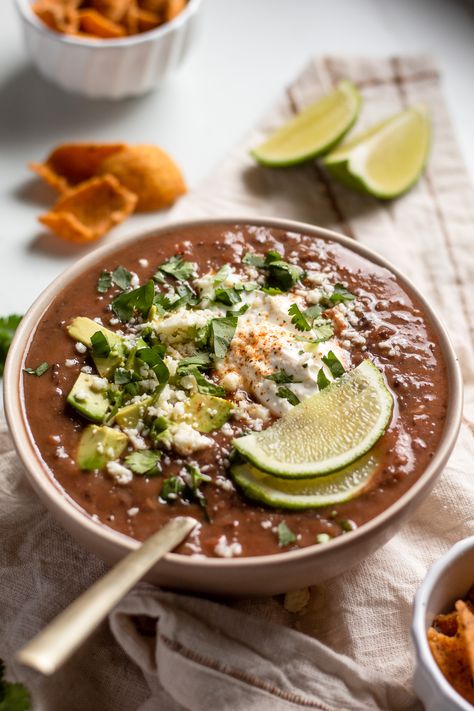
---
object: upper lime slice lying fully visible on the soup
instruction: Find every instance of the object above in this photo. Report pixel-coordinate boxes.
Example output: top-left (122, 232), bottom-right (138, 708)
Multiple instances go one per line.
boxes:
top-left (233, 360), bottom-right (393, 479)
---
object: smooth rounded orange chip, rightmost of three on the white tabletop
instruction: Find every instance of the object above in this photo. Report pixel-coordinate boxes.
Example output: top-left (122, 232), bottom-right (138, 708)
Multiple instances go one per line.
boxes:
top-left (97, 145), bottom-right (186, 211)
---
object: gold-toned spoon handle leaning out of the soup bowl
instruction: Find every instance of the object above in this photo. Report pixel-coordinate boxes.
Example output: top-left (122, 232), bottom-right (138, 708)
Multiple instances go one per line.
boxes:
top-left (16, 517), bottom-right (197, 674)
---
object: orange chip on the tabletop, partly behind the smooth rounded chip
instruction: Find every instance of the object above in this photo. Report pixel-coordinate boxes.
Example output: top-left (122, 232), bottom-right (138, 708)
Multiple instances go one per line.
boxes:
top-left (30, 143), bottom-right (125, 192)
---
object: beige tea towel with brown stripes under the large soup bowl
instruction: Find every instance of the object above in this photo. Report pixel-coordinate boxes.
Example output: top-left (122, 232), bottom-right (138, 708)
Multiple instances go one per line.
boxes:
top-left (0, 57), bottom-right (474, 711)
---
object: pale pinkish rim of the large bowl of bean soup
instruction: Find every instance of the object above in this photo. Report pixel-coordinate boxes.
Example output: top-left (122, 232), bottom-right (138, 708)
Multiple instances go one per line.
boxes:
top-left (3, 215), bottom-right (463, 570)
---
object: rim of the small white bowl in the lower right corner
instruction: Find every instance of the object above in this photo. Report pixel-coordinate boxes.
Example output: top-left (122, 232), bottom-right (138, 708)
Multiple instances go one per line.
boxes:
top-left (411, 536), bottom-right (474, 711)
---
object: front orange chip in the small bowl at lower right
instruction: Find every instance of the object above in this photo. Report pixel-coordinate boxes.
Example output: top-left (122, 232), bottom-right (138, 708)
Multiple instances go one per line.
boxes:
top-left (428, 627), bottom-right (474, 703)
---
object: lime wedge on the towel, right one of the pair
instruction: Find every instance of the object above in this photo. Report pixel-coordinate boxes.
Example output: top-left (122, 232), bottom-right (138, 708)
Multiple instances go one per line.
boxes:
top-left (324, 105), bottom-right (430, 199)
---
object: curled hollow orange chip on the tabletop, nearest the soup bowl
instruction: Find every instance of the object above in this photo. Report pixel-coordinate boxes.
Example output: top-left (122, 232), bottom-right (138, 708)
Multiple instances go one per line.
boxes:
top-left (39, 175), bottom-right (137, 242)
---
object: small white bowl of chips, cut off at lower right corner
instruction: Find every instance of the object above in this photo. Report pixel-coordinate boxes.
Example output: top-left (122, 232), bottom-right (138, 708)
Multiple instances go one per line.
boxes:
top-left (411, 536), bottom-right (474, 711)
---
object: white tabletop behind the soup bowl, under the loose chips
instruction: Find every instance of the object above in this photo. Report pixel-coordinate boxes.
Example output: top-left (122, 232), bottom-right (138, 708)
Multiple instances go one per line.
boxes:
top-left (0, 0), bottom-right (474, 315)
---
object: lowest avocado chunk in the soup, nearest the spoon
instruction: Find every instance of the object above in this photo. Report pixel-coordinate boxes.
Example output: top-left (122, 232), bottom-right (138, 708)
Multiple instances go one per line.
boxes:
top-left (76, 425), bottom-right (128, 471)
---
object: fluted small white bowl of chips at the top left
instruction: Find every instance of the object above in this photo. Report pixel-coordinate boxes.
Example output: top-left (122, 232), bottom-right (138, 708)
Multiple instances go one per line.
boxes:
top-left (16, 0), bottom-right (201, 99)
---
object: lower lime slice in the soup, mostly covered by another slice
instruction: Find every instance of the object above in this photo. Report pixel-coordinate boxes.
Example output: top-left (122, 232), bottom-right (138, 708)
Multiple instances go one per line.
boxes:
top-left (230, 454), bottom-right (378, 509)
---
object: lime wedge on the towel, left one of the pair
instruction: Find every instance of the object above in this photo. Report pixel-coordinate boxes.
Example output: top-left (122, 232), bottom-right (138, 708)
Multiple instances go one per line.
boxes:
top-left (251, 81), bottom-right (362, 167)
